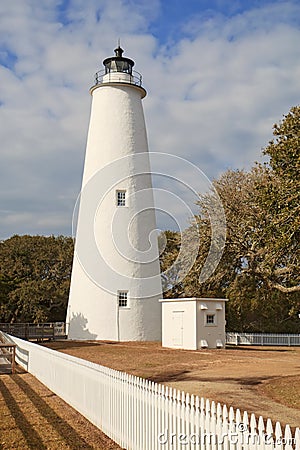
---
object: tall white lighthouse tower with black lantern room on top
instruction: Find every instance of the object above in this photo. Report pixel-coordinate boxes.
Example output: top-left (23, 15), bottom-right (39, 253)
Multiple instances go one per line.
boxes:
top-left (67, 46), bottom-right (162, 341)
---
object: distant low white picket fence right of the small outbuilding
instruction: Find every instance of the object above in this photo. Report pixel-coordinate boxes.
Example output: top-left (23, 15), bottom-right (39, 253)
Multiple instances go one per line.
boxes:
top-left (226, 332), bottom-right (300, 346)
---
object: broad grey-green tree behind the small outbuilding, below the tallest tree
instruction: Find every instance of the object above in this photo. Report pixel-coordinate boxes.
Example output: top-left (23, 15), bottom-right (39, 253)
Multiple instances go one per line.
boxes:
top-left (183, 165), bottom-right (299, 332)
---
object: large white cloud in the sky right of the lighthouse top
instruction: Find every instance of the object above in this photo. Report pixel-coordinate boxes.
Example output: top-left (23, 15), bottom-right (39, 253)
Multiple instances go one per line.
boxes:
top-left (146, 7), bottom-right (300, 176)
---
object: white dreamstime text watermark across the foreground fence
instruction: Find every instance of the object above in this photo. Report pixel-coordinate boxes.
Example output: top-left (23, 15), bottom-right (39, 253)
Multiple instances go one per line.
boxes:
top-left (158, 423), bottom-right (296, 449)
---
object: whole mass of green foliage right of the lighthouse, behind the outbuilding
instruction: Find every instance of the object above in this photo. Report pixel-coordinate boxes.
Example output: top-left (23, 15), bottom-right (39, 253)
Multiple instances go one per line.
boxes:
top-left (161, 107), bottom-right (300, 332)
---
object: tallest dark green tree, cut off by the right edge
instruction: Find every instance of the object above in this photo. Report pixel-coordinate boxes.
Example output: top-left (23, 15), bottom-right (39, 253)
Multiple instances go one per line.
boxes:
top-left (258, 106), bottom-right (300, 296)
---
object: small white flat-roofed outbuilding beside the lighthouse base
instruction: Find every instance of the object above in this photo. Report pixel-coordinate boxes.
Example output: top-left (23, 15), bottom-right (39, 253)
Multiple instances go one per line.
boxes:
top-left (160, 298), bottom-right (227, 350)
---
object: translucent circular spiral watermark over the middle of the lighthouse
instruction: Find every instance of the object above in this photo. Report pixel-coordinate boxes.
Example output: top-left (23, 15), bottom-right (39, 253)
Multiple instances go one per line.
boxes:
top-left (72, 152), bottom-right (226, 298)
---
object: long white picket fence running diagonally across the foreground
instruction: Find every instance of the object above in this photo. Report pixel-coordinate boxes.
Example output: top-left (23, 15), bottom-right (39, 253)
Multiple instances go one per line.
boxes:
top-left (2, 335), bottom-right (300, 450)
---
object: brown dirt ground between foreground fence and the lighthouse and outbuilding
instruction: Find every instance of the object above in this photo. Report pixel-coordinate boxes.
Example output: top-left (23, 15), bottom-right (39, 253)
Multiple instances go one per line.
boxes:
top-left (45, 341), bottom-right (300, 428)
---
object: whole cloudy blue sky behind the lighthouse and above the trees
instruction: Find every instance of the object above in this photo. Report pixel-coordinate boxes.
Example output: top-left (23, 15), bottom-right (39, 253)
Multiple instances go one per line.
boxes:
top-left (0, 0), bottom-right (300, 239)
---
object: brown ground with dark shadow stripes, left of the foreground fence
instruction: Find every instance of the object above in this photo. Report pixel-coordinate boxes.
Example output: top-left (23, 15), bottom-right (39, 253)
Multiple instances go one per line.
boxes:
top-left (0, 369), bottom-right (120, 450)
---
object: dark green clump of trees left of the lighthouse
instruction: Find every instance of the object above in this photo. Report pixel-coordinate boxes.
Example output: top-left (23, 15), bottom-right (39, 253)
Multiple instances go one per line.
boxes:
top-left (0, 235), bottom-right (73, 322)
